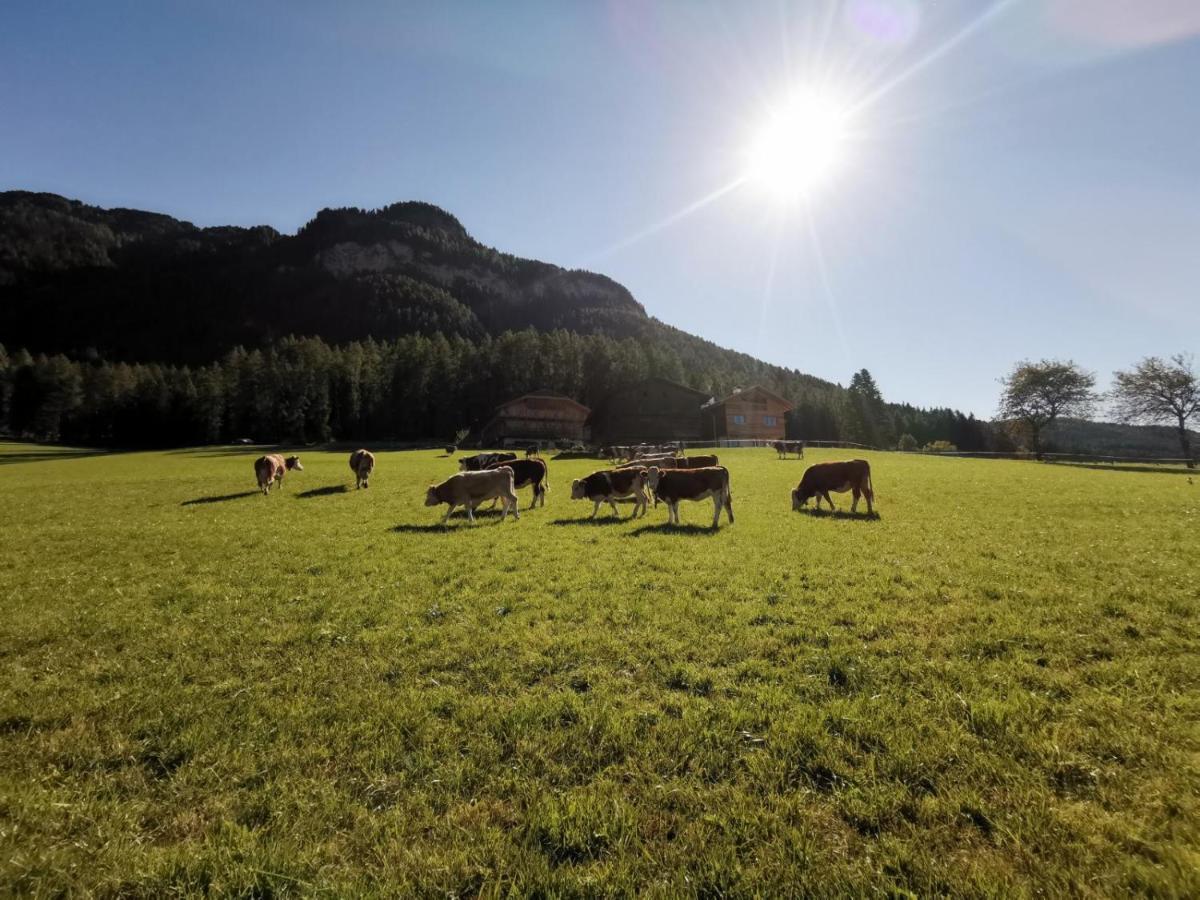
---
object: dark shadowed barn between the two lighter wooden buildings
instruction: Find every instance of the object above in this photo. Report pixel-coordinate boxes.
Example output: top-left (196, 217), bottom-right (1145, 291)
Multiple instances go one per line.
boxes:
top-left (588, 378), bottom-right (709, 444)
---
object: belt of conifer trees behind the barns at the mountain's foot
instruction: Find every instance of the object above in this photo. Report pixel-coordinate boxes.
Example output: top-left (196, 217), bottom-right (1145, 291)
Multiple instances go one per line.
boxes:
top-left (0, 329), bottom-right (1006, 450)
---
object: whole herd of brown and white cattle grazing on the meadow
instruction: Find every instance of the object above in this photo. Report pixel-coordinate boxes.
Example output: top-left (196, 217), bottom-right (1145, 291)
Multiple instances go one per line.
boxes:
top-left (254, 442), bottom-right (875, 528)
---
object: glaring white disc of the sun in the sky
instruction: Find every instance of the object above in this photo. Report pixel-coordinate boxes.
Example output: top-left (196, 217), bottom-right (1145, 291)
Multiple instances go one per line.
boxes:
top-left (746, 90), bottom-right (846, 200)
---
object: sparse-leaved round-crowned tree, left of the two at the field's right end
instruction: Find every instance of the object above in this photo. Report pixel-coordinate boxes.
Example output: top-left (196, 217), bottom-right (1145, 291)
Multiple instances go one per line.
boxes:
top-left (1000, 360), bottom-right (1097, 460)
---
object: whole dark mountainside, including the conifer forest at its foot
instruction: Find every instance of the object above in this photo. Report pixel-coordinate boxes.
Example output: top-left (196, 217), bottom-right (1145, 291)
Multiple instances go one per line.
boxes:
top-left (0, 191), bottom-right (1142, 458)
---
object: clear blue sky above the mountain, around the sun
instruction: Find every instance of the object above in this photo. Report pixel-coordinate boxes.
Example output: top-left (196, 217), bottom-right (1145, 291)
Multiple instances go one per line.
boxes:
top-left (0, 0), bottom-right (1200, 418)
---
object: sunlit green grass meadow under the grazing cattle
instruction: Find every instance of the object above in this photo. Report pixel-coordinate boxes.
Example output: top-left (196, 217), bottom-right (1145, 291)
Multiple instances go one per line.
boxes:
top-left (0, 444), bottom-right (1200, 896)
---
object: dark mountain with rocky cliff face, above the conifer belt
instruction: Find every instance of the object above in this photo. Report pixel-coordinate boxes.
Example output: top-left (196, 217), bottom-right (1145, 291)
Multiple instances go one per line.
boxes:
top-left (0, 191), bottom-right (656, 362)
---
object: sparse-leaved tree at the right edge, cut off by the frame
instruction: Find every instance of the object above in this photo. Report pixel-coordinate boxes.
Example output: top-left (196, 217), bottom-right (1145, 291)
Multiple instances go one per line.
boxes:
top-left (1110, 353), bottom-right (1200, 469)
